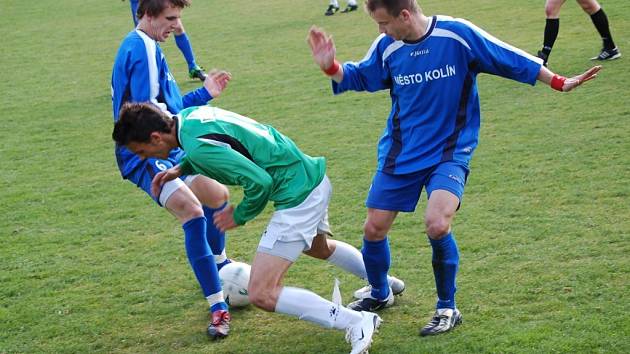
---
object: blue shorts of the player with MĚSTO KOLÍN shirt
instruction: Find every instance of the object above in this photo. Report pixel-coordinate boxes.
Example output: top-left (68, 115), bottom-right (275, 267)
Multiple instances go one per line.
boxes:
top-left (365, 161), bottom-right (469, 212)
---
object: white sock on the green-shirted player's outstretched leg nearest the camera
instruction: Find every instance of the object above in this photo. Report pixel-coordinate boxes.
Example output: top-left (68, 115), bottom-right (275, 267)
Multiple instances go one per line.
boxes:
top-left (275, 286), bottom-right (363, 329)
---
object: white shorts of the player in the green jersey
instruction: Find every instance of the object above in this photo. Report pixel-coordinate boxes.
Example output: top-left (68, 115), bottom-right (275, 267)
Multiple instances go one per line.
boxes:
top-left (258, 176), bottom-right (332, 261)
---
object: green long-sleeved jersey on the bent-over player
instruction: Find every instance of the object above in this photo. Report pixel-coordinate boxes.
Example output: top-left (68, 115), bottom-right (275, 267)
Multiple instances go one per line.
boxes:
top-left (175, 106), bottom-right (326, 225)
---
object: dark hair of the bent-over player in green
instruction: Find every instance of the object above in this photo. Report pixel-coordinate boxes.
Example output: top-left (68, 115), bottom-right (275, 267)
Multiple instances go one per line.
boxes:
top-left (112, 103), bottom-right (173, 146)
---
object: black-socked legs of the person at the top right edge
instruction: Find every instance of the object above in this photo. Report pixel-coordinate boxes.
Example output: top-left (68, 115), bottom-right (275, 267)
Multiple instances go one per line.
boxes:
top-left (538, 0), bottom-right (621, 66)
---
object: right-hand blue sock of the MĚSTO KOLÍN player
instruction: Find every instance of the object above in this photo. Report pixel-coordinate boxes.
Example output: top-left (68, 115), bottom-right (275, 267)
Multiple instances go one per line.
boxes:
top-left (429, 233), bottom-right (459, 309)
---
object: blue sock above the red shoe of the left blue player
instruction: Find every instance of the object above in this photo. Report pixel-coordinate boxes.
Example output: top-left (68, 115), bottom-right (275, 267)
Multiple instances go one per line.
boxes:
top-left (182, 216), bottom-right (227, 311)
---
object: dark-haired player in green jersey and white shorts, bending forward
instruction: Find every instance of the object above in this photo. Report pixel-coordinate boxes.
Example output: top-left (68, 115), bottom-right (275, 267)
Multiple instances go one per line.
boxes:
top-left (112, 92), bottom-right (396, 353)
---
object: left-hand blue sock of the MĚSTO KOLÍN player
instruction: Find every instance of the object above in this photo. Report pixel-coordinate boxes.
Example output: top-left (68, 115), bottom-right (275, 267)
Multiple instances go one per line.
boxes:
top-left (361, 236), bottom-right (390, 300)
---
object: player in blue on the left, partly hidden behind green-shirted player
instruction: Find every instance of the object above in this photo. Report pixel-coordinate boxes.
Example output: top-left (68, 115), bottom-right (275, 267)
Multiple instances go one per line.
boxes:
top-left (111, 0), bottom-right (230, 338)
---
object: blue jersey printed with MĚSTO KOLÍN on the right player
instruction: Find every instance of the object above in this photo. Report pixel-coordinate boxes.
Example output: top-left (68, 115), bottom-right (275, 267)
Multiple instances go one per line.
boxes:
top-left (332, 16), bottom-right (542, 174)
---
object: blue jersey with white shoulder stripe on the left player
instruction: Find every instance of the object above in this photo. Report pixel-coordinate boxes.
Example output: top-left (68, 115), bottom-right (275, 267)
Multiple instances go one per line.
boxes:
top-left (111, 29), bottom-right (212, 177)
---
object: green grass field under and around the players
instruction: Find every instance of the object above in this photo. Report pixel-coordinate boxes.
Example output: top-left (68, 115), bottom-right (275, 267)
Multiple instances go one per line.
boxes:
top-left (0, 0), bottom-right (630, 353)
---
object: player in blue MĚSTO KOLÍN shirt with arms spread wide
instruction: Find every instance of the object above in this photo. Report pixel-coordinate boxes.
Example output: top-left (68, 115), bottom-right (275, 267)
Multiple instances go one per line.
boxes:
top-left (308, 0), bottom-right (600, 336)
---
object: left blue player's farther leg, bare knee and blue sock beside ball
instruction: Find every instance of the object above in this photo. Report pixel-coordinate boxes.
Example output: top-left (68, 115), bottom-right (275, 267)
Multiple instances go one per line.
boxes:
top-left (190, 175), bottom-right (235, 270)
